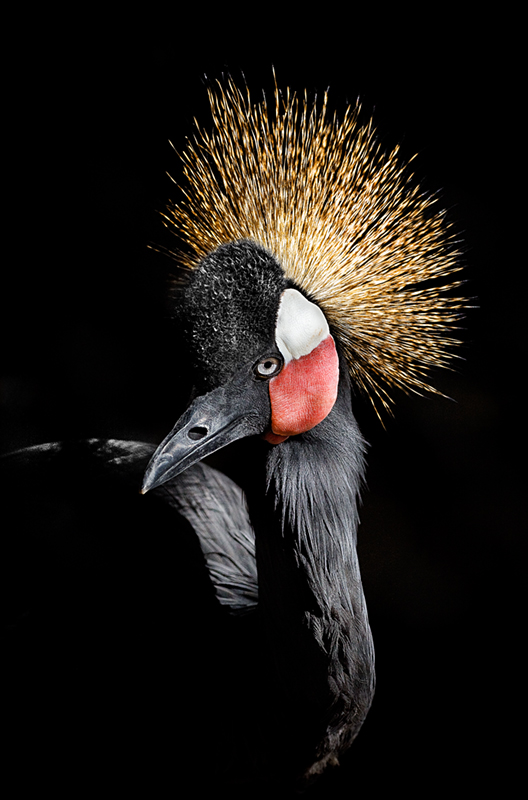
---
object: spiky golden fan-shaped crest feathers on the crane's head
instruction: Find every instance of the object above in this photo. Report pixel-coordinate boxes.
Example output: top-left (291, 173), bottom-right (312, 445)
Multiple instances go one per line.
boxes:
top-left (160, 73), bottom-right (464, 412)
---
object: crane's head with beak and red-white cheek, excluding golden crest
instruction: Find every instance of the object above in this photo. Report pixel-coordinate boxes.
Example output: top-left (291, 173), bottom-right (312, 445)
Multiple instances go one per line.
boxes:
top-left (143, 240), bottom-right (339, 492)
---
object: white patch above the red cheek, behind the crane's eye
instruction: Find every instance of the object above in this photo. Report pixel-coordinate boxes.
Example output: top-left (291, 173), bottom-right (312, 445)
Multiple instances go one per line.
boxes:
top-left (275, 289), bottom-right (330, 364)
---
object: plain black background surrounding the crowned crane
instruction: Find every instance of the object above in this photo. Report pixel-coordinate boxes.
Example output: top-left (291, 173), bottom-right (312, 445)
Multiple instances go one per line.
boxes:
top-left (0, 15), bottom-right (526, 797)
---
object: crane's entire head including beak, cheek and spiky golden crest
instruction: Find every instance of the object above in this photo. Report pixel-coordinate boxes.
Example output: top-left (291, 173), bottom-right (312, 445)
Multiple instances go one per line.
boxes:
top-left (139, 79), bottom-right (464, 491)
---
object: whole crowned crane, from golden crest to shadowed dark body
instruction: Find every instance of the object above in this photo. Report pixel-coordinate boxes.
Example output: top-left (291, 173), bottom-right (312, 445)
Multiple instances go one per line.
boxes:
top-left (2, 81), bottom-right (463, 785)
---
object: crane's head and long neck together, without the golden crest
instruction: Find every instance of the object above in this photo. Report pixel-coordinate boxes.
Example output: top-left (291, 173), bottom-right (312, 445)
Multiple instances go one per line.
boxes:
top-left (139, 236), bottom-right (374, 780)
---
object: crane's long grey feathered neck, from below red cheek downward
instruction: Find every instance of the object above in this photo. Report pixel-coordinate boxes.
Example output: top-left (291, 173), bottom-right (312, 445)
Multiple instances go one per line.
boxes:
top-left (253, 372), bottom-right (374, 771)
